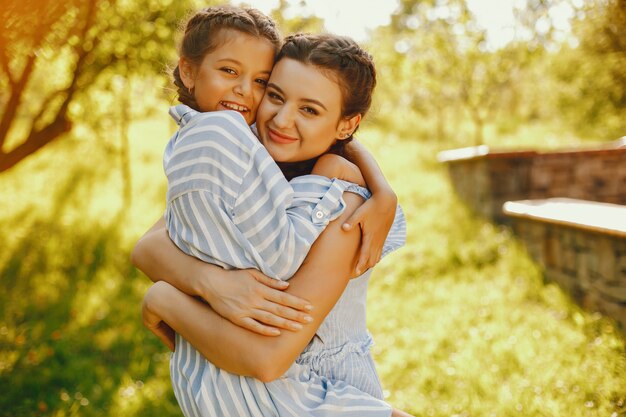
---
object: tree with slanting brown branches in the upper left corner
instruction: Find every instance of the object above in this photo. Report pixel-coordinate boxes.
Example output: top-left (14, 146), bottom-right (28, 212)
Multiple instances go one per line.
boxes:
top-left (0, 0), bottom-right (202, 172)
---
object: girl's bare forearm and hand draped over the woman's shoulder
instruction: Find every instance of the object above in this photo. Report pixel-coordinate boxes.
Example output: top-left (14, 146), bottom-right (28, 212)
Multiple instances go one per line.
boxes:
top-left (343, 141), bottom-right (398, 275)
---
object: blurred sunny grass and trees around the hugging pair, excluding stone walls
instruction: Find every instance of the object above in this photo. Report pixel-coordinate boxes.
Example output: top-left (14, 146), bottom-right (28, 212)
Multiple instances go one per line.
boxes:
top-left (0, 0), bottom-right (626, 417)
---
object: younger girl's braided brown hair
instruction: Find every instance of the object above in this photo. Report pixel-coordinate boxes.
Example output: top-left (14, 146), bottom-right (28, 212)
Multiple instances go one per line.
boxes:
top-left (173, 6), bottom-right (281, 110)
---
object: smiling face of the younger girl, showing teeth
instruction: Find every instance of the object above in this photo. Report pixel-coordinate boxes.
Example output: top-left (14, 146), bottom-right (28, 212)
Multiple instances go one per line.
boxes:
top-left (179, 29), bottom-right (274, 124)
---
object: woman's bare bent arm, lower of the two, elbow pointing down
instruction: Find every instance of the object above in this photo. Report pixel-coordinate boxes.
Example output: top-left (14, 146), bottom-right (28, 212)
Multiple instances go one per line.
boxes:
top-left (144, 193), bottom-right (362, 381)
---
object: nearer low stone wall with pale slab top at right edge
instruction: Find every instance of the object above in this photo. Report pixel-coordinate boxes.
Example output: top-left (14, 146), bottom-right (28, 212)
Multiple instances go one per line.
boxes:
top-left (502, 198), bottom-right (626, 330)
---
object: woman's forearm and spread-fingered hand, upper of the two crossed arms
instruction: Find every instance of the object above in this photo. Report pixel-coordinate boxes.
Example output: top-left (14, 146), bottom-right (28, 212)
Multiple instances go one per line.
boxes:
top-left (131, 218), bottom-right (310, 336)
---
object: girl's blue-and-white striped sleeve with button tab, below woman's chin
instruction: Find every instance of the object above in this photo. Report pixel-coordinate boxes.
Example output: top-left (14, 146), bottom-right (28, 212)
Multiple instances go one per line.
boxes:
top-left (234, 152), bottom-right (345, 279)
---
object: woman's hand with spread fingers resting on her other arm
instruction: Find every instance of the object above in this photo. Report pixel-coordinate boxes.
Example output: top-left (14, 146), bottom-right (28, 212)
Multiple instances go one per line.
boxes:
top-left (206, 269), bottom-right (313, 336)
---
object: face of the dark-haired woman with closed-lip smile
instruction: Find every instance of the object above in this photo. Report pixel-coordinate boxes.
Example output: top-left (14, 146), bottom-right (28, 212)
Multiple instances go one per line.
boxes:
top-left (257, 58), bottom-right (361, 162)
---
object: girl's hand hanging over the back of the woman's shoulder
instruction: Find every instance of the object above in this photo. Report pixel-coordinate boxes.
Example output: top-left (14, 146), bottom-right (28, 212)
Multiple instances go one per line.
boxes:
top-left (342, 192), bottom-right (398, 276)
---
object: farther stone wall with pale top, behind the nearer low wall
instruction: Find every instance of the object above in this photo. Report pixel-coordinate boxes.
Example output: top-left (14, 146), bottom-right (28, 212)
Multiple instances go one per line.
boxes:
top-left (439, 138), bottom-right (626, 223)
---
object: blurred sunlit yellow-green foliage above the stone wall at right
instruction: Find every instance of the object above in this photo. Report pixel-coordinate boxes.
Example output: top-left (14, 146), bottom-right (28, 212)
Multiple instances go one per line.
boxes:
top-left (370, 0), bottom-right (626, 146)
